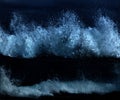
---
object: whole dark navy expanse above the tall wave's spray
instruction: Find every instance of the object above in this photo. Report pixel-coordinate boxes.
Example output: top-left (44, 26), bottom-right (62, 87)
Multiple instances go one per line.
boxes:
top-left (0, 0), bottom-right (120, 28)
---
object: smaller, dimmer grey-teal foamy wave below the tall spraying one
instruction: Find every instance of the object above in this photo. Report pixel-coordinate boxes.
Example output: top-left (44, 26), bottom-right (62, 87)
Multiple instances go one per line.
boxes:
top-left (0, 68), bottom-right (119, 98)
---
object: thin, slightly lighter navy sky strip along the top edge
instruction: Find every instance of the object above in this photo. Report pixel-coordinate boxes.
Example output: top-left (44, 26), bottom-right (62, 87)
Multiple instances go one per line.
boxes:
top-left (0, 0), bottom-right (120, 7)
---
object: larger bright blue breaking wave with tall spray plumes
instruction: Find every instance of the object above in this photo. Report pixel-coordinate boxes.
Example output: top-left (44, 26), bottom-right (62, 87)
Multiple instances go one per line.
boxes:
top-left (0, 12), bottom-right (120, 58)
